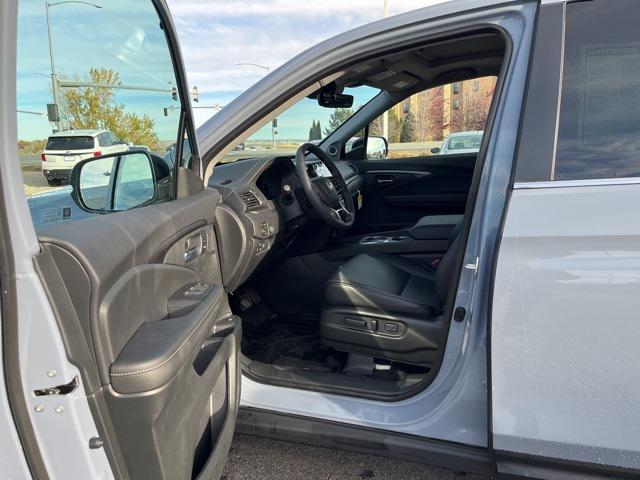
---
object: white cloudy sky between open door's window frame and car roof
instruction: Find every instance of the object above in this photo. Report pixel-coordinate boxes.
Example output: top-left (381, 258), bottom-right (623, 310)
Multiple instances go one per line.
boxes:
top-left (169, 0), bottom-right (443, 101)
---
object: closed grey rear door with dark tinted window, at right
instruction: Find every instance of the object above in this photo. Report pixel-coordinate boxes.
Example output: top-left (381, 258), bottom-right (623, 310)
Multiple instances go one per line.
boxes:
top-left (496, 0), bottom-right (640, 479)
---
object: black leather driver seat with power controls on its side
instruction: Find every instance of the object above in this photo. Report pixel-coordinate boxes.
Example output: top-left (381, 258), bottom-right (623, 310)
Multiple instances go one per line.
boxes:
top-left (320, 224), bottom-right (461, 366)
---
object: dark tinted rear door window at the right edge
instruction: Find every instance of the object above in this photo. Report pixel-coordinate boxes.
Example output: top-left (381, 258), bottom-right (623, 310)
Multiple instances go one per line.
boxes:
top-left (554, 0), bottom-right (640, 180)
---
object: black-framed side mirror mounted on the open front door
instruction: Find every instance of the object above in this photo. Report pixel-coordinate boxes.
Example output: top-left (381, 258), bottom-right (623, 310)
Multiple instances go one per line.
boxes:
top-left (70, 150), bottom-right (158, 213)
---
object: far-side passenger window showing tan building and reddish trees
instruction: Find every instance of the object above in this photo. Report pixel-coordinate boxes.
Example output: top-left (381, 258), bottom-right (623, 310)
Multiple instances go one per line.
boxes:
top-left (362, 77), bottom-right (496, 160)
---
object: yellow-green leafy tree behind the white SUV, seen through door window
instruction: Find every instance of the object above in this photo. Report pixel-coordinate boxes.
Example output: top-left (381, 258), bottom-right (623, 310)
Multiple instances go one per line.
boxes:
top-left (61, 68), bottom-right (159, 150)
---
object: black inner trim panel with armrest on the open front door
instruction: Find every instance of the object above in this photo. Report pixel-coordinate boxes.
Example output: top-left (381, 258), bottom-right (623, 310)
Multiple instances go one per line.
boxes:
top-left (38, 190), bottom-right (241, 479)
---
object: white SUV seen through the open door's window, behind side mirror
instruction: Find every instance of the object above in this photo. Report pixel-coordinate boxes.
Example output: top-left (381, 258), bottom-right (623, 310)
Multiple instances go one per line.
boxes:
top-left (40, 130), bottom-right (129, 186)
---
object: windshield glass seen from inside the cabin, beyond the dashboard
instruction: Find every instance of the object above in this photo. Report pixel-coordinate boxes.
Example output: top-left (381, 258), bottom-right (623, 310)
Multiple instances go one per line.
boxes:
top-left (222, 86), bottom-right (380, 163)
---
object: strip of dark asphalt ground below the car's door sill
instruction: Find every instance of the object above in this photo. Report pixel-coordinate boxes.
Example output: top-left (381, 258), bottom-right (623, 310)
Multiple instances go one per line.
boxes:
top-left (222, 435), bottom-right (489, 480)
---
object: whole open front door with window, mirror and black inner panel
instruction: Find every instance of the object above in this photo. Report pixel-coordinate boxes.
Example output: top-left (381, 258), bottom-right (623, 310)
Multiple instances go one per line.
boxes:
top-left (16, 0), bottom-right (241, 479)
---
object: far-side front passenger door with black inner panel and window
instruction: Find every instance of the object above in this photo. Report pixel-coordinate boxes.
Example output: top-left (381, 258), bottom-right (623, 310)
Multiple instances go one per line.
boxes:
top-left (354, 77), bottom-right (496, 233)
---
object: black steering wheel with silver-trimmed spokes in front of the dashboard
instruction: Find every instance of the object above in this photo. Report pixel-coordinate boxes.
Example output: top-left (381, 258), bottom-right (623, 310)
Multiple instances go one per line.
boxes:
top-left (296, 143), bottom-right (356, 230)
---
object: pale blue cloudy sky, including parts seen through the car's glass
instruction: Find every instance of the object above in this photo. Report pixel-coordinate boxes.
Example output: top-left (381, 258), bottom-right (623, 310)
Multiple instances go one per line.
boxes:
top-left (17, 0), bottom-right (442, 140)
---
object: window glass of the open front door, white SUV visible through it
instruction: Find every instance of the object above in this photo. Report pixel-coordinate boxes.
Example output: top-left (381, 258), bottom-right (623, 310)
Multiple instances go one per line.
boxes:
top-left (17, 0), bottom-right (182, 227)
